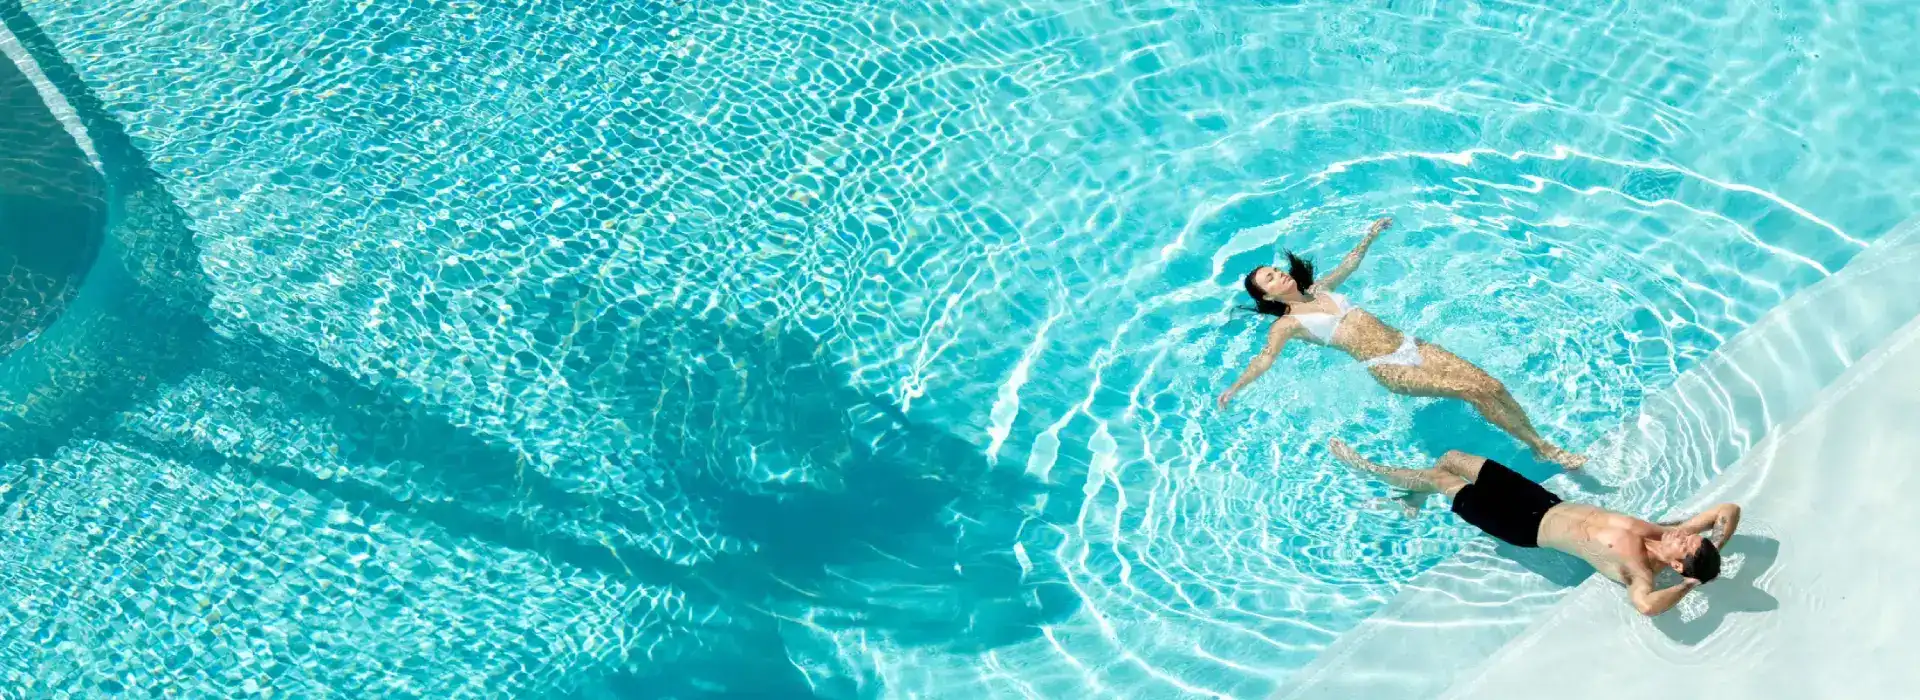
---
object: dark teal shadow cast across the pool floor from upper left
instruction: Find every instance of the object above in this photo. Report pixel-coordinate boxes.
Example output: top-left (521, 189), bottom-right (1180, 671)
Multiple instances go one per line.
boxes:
top-left (0, 0), bottom-right (1077, 692)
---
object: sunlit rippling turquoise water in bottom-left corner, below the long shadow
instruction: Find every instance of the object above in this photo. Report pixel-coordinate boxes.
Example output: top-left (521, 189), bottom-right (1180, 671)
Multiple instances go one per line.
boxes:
top-left (0, 441), bottom-right (683, 698)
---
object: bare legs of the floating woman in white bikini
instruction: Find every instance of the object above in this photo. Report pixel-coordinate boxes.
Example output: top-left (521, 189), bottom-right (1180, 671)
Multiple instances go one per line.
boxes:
top-left (1373, 345), bottom-right (1586, 470)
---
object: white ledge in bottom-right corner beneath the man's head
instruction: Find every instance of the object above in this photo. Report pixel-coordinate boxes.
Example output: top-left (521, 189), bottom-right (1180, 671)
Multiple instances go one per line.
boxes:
top-left (1446, 293), bottom-right (1920, 698)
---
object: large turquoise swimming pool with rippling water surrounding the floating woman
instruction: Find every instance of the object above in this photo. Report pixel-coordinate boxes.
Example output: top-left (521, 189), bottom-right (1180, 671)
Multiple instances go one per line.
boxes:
top-left (0, 0), bottom-right (1920, 698)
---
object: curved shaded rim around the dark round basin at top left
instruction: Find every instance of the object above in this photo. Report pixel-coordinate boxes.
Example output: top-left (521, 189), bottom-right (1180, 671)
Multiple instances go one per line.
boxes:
top-left (0, 12), bottom-right (207, 458)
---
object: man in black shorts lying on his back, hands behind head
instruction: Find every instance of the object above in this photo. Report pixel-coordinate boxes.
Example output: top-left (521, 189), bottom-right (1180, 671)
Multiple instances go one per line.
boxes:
top-left (1331, 439), bottom-right (1740, 616)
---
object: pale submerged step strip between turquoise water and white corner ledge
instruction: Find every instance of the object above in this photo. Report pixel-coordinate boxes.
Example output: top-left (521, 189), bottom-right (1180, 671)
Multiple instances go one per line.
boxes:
top-left (1279, 221), bottom-right (1920, 700)
